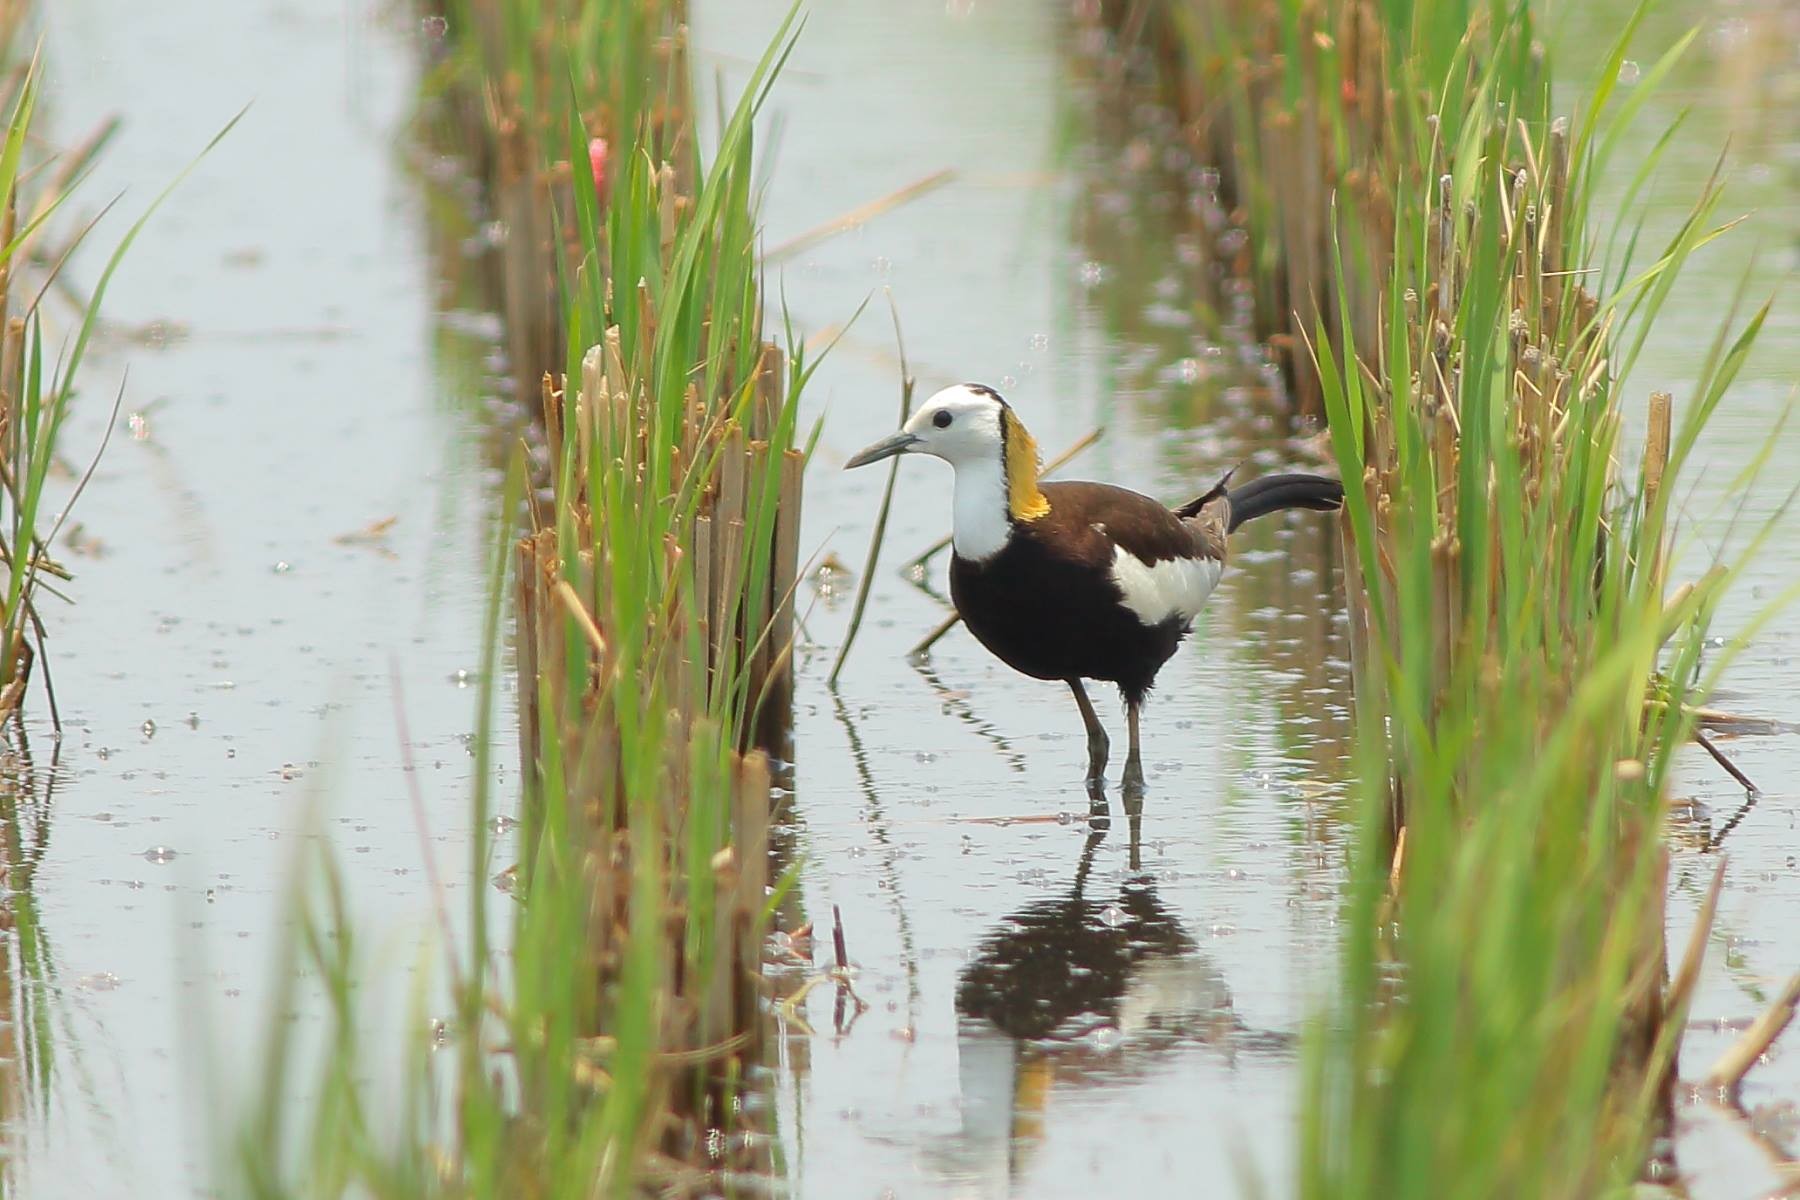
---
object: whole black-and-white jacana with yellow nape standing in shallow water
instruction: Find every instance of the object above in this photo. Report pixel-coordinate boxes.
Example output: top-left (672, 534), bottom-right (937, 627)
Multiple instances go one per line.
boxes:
top-left (844, 383), bottom-right (1343, 788)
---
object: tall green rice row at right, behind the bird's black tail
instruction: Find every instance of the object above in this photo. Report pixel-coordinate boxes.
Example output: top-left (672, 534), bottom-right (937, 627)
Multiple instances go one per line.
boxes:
top-left (1112, 0), bottom-right (1762, 1196)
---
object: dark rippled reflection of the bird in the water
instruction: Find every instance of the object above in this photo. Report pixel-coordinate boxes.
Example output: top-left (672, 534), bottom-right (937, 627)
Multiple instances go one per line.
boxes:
top-left (925, 793), bottom-right (1292, 1198)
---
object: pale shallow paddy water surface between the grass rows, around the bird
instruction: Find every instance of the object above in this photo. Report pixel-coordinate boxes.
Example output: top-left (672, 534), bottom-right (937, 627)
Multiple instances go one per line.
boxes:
top-left (4, 0), bottom-right (1800, 1198)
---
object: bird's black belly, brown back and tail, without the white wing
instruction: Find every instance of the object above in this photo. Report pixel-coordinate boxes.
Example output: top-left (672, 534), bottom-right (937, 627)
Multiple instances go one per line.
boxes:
top-left (950, 475), bottom-right (1343, 705)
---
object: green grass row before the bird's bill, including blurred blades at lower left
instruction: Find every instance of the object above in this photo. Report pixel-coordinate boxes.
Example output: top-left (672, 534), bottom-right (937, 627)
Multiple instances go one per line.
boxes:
top-left (232, 0), bottom-right (810, 1198)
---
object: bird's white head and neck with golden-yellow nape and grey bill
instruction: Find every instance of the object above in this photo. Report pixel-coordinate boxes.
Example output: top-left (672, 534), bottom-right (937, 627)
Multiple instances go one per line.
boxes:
top-left (844, 383), bottom-right (1049, 558)
